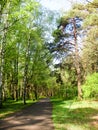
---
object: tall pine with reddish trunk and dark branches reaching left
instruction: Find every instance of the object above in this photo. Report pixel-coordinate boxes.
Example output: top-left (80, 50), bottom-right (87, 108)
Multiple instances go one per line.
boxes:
top-left (51, 10), bottom-right (82, 99)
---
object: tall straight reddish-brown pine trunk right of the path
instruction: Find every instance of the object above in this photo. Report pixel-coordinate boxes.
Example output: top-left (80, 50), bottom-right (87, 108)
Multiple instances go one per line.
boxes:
top-left (73, 18), bottom-right (82, 99)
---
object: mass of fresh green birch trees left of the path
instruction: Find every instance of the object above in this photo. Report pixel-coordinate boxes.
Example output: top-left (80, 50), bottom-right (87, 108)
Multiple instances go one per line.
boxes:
top-left (0, 0), bottom-right (56, 105)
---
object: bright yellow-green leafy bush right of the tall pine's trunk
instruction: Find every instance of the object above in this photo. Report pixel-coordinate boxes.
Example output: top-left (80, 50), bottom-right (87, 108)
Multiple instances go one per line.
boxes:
top-left (82, 73), bottom-right (98, 98)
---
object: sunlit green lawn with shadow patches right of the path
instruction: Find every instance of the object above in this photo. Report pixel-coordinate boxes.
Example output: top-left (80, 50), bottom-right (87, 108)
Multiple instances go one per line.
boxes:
top-left (52, 99), bottom-right (98, 130)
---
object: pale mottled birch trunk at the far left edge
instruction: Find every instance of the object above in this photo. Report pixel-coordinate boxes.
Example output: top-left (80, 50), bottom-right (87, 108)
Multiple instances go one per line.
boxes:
top-left (0, 2), bottom-right (10, 107)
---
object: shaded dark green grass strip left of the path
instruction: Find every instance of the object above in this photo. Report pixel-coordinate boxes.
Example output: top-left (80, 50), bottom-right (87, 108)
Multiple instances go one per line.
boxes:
top-left (0, 100), bottom-right (34, 119)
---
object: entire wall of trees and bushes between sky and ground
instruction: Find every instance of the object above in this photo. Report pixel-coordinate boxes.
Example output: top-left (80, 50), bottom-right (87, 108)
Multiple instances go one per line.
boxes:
top-left (0, 0), bottom-right (98, 107)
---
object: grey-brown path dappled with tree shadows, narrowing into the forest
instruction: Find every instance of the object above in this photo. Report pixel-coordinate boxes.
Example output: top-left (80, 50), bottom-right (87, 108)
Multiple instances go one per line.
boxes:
top-left (0, 99), bottom-right (54, 130)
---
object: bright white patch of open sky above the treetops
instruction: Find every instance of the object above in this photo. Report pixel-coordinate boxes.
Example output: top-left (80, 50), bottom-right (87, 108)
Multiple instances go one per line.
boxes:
top-left (40, 0), bottom-right (86, 11)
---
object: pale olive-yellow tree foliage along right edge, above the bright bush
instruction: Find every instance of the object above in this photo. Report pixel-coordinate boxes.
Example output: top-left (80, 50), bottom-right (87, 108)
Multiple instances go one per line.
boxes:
top-left (82, 0), bottom-right (98, 75)
